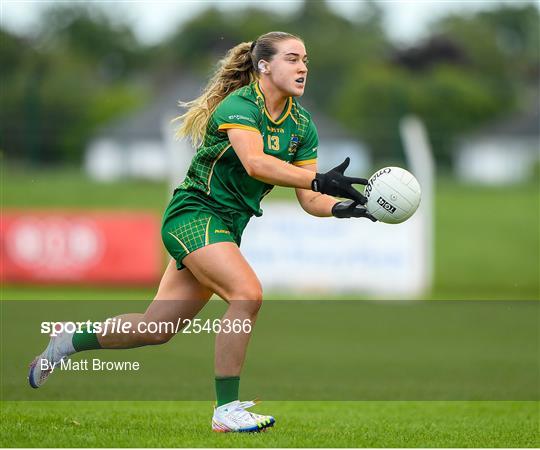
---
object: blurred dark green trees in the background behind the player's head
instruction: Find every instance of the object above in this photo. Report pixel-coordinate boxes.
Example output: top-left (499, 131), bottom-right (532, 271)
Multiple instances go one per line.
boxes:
top-left (0, 1), bottom-right (540, 166)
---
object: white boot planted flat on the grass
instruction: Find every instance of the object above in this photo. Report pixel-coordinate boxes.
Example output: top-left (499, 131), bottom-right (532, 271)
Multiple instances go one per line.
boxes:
top-left (212, 400), bottom-right (276, 433)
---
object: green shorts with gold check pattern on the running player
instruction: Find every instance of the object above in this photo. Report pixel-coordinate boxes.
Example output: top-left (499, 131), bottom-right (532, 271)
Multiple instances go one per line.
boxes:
top-left (161, 189), bottom-right (251, 270)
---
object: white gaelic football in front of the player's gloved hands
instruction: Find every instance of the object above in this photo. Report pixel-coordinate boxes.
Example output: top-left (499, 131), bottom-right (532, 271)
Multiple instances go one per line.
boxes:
top-left (364, 167), bottom-right (422, 223)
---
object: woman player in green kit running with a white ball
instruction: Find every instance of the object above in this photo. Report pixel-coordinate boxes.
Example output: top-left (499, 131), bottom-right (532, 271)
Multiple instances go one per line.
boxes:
top-left (29, 32), bottom-right (375, 432)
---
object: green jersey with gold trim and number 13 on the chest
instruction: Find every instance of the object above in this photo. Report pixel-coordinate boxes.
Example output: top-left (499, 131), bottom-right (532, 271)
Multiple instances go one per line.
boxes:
top-left (179, 82), bottom-right (319, 216)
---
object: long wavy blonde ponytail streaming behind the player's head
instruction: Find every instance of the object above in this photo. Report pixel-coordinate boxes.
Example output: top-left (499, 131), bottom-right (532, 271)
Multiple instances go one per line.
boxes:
top-left (173, 42), bottom-right (256, 147)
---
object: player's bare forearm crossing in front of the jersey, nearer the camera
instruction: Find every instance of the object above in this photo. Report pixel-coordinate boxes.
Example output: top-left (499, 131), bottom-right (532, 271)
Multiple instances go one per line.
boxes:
top-left (244, 154), bottom-right (315, 190)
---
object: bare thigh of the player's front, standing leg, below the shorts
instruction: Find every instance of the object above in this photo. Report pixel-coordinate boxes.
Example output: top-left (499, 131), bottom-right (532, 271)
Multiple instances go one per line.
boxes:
top-left (182, 242), bottom-right (262, 301)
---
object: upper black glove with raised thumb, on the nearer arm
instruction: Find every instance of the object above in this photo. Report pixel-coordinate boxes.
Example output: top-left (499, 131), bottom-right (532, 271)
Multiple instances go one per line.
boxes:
top-left (311, 157), bottom-right (368, 205)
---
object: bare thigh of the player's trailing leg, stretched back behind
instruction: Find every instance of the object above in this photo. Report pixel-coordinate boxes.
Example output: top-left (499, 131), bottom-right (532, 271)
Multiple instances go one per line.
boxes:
top-left (145, 260), bottom-right (213, 322)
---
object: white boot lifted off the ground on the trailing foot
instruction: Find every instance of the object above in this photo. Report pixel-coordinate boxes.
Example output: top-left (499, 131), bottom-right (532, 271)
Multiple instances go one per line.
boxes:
top-left (28, 332), bottom-right (75, 389)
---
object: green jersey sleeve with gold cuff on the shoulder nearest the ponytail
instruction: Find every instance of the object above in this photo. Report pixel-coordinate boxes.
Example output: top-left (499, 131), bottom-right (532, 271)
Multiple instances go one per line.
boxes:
top-left (214, 95), bottom-right (261, 133)
